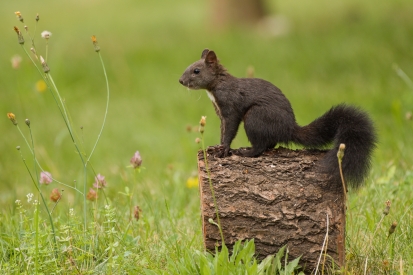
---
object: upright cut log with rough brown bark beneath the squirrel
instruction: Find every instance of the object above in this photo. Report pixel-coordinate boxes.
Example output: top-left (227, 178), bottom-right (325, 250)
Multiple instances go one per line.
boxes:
top-left (198, 146), bottom-right (345, 271)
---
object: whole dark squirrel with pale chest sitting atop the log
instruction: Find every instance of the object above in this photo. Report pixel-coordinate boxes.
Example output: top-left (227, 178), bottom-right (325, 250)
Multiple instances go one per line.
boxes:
top-left (179, 49), bottom-right (377, 187)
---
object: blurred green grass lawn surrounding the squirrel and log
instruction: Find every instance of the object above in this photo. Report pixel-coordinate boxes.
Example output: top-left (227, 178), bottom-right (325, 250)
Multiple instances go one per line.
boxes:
top-left (0, 0), bottom-right (413, 274)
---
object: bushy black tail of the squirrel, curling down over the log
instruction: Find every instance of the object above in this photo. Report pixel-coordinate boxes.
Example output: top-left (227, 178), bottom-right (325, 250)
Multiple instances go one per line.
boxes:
top-left (295, 104), bottom-right (377, 188)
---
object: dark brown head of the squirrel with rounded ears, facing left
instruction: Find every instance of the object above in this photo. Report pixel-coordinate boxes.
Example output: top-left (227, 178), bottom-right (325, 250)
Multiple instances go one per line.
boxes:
top-left (179, 49), bottom-right (224, 90)
